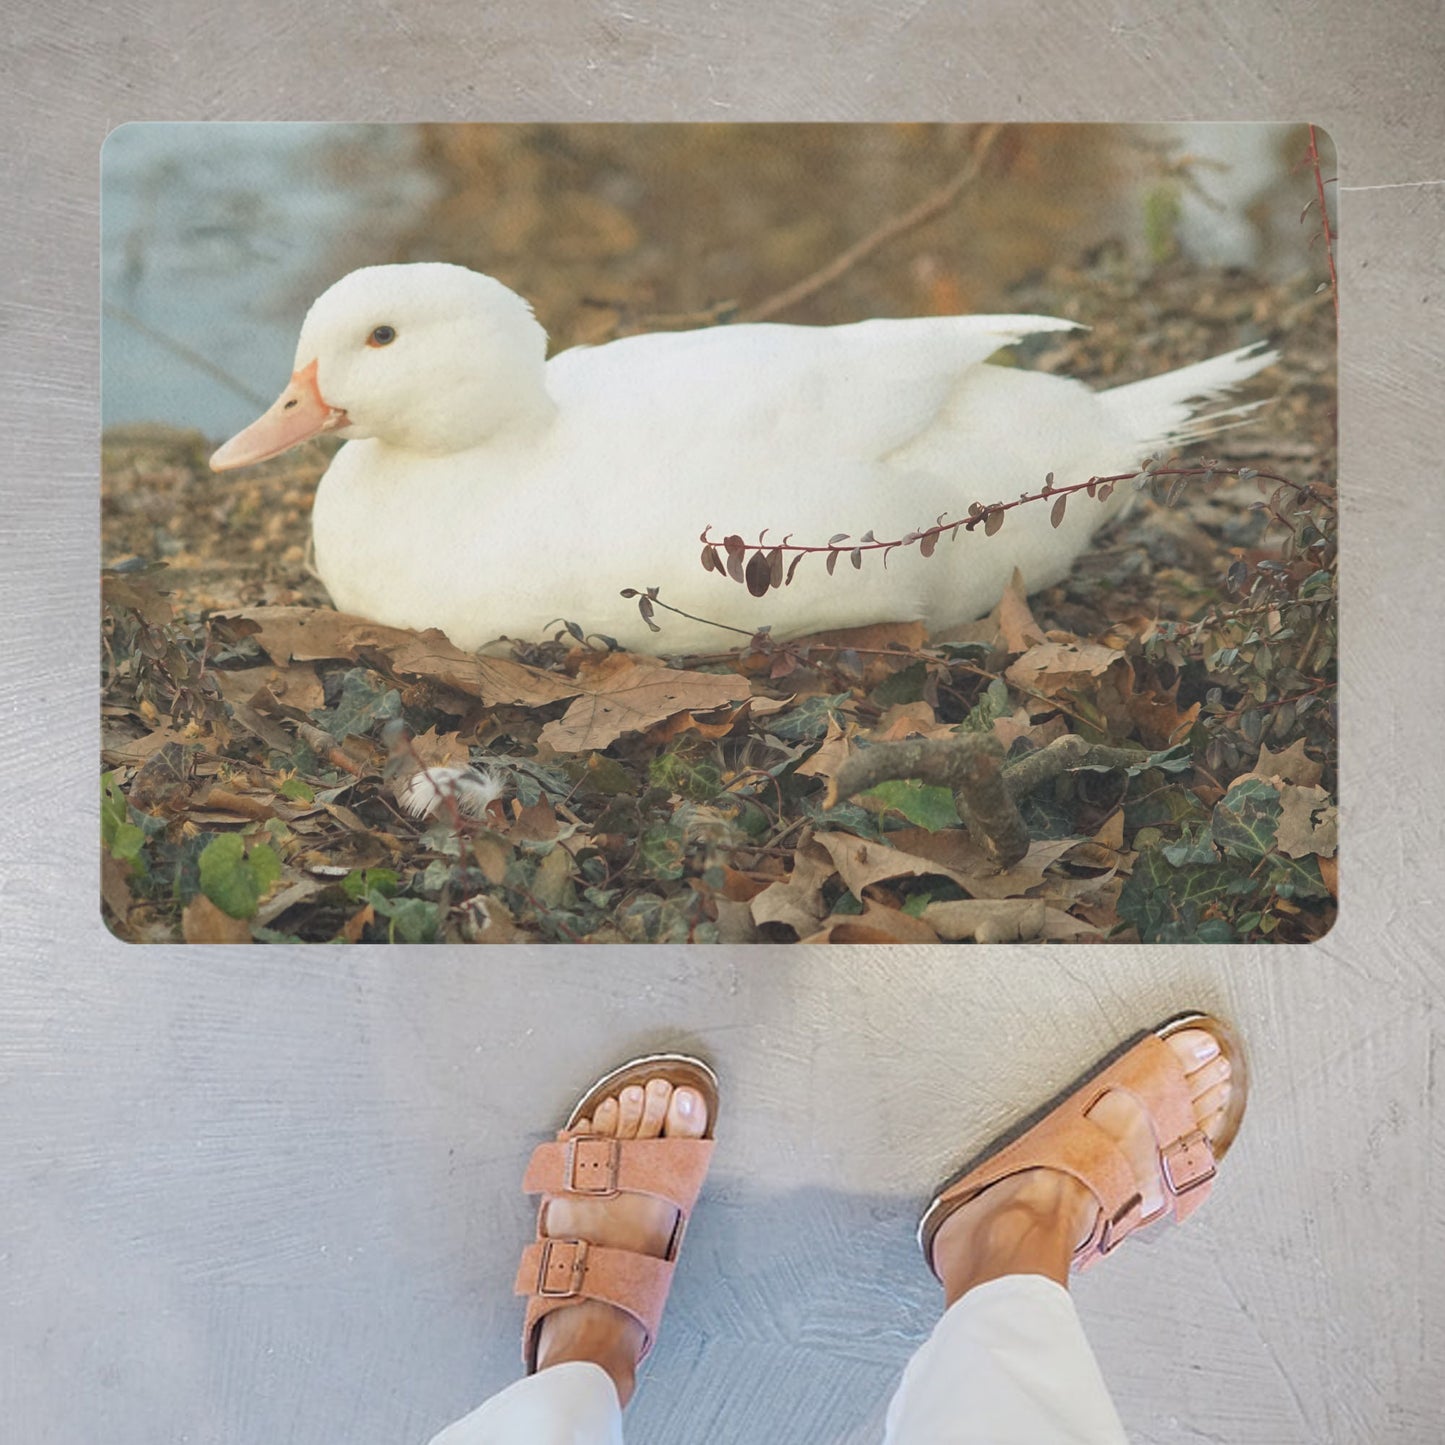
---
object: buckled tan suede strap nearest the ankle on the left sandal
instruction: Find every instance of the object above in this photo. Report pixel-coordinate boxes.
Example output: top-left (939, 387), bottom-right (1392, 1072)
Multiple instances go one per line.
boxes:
top-left (513, 1220), bottom-right (681, 1374)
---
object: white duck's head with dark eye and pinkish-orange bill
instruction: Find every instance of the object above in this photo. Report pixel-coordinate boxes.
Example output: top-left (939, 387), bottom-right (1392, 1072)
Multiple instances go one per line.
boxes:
top-left (211, 262), bottom-right (552, 471)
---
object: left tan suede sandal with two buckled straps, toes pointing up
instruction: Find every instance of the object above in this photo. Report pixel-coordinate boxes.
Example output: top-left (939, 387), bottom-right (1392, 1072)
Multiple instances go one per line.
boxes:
top-left (516, 1053), bottom-right (718, 1374)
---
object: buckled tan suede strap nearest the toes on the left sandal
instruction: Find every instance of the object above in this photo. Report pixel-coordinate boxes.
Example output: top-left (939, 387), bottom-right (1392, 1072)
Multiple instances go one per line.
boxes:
top-left (522, 1130), bottom-right (714, 1217)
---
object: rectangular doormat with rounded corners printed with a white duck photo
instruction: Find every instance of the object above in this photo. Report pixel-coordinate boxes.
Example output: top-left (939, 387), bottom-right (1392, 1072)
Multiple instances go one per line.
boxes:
top-left (100, 123), bottom-right (1348, 944)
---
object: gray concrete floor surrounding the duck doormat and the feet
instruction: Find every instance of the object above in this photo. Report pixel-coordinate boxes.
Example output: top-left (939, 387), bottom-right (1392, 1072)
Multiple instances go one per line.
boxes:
top-left (0, 0), bottom-right (1445, 1445)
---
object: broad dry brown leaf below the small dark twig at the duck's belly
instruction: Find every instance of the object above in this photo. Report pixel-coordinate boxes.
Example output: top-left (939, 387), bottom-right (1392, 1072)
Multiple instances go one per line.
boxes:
top-left (540, 653), bottom-right (751, 753)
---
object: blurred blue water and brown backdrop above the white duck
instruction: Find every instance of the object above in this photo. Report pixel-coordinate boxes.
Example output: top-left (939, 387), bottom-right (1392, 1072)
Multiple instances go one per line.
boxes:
top-left (101, 123), bottom-right (1334, 438)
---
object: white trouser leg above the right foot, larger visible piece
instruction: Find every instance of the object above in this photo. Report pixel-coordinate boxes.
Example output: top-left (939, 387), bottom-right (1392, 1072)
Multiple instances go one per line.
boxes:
top-left (884, 1274), bottom-right (1126, 1445)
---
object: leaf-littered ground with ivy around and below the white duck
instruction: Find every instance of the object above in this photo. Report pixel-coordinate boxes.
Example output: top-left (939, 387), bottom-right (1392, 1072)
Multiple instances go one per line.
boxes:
top-left (100, 250), bottom-right (1337, 942)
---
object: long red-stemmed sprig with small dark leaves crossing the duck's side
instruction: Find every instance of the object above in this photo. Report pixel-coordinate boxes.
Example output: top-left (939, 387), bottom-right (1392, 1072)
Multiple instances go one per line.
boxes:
top-left (699, 455), bottom-right (1334, 597)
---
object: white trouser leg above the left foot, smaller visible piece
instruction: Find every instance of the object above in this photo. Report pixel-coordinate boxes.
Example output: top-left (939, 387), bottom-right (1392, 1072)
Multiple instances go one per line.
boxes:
top-left (432, 1360), bottom-right (623, 1445)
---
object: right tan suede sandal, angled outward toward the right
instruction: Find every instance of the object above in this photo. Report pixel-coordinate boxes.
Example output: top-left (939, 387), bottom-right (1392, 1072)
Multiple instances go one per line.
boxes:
top-left (918, 1013), bottom-right (1248, 1274)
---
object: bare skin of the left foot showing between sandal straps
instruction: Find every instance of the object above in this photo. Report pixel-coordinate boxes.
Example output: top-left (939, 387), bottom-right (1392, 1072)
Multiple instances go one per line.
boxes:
top-left (538, 1078), bottom-right (708, 1405)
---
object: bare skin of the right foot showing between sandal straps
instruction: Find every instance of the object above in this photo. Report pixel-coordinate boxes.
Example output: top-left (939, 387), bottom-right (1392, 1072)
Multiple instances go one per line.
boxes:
top-left (932, 1029), bottom-right (1231, 1305)
